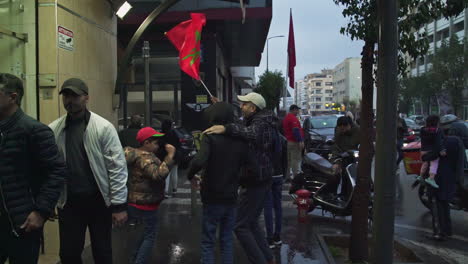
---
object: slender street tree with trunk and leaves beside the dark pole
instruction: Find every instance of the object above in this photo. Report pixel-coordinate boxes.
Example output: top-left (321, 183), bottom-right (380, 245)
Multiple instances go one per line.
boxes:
top-left (333, 0), bottom-right (462, 262)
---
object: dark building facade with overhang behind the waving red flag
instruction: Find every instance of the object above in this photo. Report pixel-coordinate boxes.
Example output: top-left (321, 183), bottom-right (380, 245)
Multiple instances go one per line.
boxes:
top-left (118, 0), bottom-right (272, 130)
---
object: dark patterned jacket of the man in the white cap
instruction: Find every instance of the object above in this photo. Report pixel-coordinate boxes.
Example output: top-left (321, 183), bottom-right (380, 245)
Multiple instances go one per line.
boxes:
top-left (226, 109), bottom-right (278, 187)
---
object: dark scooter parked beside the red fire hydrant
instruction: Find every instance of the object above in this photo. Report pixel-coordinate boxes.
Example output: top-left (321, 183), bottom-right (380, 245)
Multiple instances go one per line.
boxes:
top-left (289, 151), bottom-right (373, 222)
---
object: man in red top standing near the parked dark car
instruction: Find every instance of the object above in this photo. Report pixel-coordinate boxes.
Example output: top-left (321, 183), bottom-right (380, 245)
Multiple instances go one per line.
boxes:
top-left (283, 105), bottom-right (304, 181)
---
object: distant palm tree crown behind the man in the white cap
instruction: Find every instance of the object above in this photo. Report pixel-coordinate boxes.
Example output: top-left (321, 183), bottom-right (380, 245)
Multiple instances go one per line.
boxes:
top-left (255, 71), bottom-right (286, 110)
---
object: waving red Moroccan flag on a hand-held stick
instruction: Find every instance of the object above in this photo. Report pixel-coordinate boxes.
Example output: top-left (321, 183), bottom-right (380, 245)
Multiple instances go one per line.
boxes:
top-left (166, 13), bottom-right (206, 80)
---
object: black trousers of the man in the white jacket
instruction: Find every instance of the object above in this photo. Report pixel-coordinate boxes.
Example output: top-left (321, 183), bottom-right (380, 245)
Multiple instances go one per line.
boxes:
top-left (58, 193), bottom-right (112, 264)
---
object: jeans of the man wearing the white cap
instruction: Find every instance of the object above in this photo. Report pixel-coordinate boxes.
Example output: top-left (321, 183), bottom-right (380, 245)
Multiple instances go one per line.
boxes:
top-left (235, 183), bottom-right (273, 264)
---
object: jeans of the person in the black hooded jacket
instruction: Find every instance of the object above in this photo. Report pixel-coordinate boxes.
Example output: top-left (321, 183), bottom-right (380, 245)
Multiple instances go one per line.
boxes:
top-left (201, 204), bottom-right (237, 264)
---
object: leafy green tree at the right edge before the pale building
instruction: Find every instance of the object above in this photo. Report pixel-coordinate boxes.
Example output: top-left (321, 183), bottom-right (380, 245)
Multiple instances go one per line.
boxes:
top-left (425, 34), bottom-right (468, 114)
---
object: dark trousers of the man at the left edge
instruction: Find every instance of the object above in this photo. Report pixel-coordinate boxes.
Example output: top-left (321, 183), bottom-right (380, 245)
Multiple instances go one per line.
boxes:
top-left (0, 215), bottom-right (42, 264)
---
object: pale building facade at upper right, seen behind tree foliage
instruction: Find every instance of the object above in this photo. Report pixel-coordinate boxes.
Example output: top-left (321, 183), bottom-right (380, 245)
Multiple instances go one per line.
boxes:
top-left (410, 9), bottom-right (468, 120)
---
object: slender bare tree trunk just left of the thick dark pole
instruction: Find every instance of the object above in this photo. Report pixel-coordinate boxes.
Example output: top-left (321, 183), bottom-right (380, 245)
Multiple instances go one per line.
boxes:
top-left (349, 41), bottom-right (375, 263)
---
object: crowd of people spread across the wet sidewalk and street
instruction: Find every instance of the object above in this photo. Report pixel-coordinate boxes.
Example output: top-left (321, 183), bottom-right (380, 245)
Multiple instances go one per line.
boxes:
top-left (0, 74), bottom-right (468, 264)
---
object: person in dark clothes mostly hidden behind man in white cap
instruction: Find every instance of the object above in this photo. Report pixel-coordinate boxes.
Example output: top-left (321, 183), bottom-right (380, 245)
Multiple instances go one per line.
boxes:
top-left (264, 121), bottom-right (288, 248)
